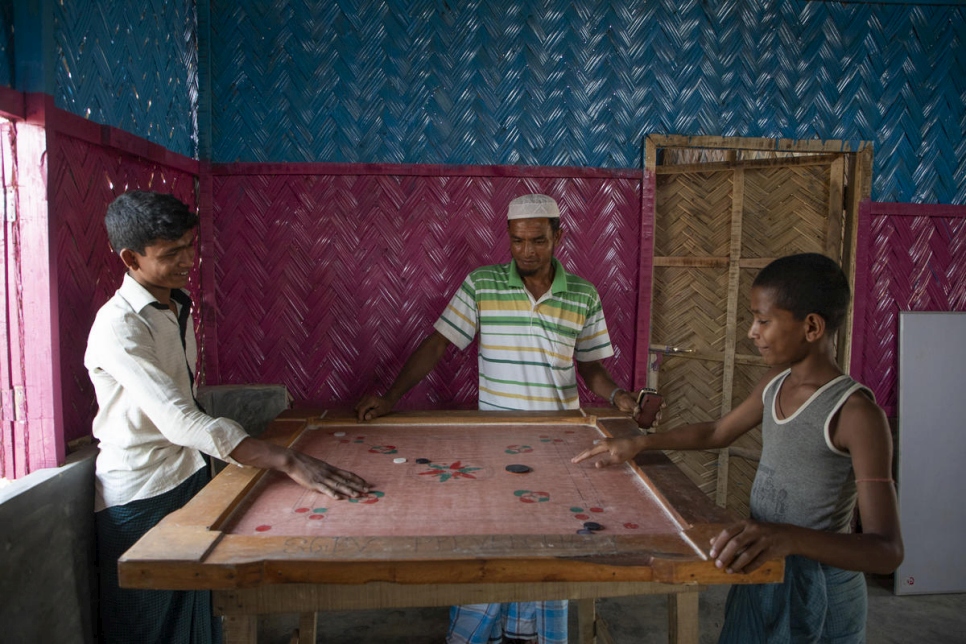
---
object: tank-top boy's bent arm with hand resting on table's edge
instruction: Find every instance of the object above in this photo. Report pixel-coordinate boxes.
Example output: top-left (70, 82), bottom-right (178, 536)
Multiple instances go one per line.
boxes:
top-left (711, 393), bottom-right (903, 574)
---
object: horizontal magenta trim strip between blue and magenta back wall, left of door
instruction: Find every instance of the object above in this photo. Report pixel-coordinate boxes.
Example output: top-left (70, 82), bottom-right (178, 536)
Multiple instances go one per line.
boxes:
top-left (211, 163), bottom-right (641, 180)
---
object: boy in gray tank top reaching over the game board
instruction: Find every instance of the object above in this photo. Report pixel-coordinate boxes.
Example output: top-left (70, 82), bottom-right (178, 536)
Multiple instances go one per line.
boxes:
top-left (573, 253), bottom-right (903, 643)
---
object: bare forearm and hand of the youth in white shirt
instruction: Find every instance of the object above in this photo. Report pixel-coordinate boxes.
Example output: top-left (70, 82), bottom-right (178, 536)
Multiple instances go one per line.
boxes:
top-left (230, 437), bottom-right (369, 499)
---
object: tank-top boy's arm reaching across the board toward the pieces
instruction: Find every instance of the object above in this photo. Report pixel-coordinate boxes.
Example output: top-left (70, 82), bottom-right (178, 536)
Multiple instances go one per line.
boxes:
top-left (572, 369), bottom-right (781, 467)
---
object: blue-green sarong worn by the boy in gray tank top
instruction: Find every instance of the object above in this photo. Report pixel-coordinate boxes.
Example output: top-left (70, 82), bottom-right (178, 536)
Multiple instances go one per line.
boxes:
top-left (718, 556), bottom-right (868, 644)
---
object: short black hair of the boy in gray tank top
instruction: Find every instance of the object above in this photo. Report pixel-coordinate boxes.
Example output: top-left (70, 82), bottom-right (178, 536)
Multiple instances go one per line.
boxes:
top-left (752, 253), bottom-right (851, 333)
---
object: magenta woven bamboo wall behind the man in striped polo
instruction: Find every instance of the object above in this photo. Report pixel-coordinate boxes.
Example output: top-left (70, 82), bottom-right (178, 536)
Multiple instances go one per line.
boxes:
top-left (206, 165), bottom-right (647, 408)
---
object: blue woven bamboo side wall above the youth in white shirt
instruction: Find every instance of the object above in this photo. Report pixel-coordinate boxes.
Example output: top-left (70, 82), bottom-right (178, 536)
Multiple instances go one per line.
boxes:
top-left (52, 0), bottom-right (198, 158)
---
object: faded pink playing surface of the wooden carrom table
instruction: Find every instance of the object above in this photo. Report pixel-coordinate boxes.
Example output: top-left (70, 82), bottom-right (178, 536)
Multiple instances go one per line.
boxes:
top-left (226, 424), bottom-right (678, 537)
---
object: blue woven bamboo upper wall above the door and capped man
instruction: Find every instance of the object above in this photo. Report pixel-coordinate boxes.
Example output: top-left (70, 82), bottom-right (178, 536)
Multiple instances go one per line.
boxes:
top-left (208, 0), bottom-right (966, 203)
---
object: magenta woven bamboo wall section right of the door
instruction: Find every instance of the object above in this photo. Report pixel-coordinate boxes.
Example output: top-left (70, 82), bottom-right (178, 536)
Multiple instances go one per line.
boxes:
top-left (851, 202), bottom-right (966, 417)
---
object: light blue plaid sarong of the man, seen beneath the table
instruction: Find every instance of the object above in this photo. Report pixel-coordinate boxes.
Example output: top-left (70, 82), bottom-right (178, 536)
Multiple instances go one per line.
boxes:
top-left (446, 600), bottom-right (567, 644)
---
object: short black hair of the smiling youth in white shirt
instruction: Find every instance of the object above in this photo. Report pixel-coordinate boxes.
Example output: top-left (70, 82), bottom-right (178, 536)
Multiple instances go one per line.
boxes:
top-left (104, 190), bottom-right (198, 255)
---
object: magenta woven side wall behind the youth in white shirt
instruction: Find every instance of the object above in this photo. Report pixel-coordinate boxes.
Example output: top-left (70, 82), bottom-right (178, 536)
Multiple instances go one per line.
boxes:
top-left (48, 126), bottom-right (198, 441)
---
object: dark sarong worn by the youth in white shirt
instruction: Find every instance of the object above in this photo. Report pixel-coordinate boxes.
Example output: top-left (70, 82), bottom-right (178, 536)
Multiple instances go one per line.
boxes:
top-left (94, 467), bottom-right (221, 644)
